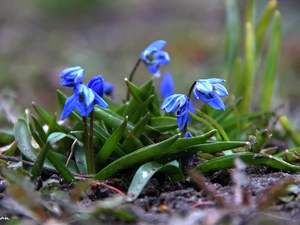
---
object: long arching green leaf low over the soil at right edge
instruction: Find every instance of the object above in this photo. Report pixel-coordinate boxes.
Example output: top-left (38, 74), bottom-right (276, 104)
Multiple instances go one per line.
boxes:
top-left (195, 152), bottom-right (300, 172)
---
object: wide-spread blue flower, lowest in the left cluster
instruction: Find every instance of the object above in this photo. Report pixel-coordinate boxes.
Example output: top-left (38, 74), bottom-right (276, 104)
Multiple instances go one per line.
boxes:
top-left (61, 84), bottom-right (108, 120)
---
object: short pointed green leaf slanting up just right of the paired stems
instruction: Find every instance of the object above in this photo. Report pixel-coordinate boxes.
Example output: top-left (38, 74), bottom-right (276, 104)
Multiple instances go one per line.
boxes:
top-left (96, 117), bottom-right (128, 167)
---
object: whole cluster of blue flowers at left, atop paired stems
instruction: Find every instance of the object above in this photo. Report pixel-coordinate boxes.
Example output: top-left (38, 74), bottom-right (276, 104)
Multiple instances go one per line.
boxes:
top-left (59, 66), bottom-right (114, 120)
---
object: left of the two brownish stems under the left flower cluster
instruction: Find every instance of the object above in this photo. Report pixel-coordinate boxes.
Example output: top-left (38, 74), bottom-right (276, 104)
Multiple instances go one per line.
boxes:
top-left (82, 116), bottom-right (94, 174)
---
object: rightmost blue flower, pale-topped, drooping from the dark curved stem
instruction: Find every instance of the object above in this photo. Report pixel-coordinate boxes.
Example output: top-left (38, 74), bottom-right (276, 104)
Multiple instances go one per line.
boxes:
top-left (194, 78), bottom-right (229, 110)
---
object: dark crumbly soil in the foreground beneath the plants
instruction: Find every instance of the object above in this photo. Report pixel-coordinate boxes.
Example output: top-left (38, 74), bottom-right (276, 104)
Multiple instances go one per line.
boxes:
top-left (0, 163), bottom-right (300, 225)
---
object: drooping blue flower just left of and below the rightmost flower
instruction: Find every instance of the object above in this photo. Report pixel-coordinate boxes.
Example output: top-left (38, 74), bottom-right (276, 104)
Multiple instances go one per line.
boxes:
top-left (161, 94), bottom-right (189, 130)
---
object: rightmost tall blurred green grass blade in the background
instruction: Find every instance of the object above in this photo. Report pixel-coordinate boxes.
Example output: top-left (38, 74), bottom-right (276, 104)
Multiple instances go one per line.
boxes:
top-left (260, 11), bottom-right (281, 111)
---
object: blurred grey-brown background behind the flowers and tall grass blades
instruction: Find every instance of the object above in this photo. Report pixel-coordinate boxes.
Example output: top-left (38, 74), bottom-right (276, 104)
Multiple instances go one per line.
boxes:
top-left (0, 0), bottom-right (300, 126)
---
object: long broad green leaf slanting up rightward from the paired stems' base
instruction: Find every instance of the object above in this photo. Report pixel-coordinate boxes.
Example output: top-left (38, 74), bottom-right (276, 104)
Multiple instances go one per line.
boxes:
top-left (94, 134), bottom-right (180, 180)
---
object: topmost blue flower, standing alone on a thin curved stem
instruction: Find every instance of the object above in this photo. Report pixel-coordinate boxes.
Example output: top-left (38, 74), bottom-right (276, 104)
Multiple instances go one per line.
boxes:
top-left (140, 40), bottom-right (170, 77)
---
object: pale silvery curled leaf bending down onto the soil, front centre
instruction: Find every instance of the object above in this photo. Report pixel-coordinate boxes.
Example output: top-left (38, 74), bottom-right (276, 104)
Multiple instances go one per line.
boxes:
top-left (126, 161), bottom-right (184, 202)
